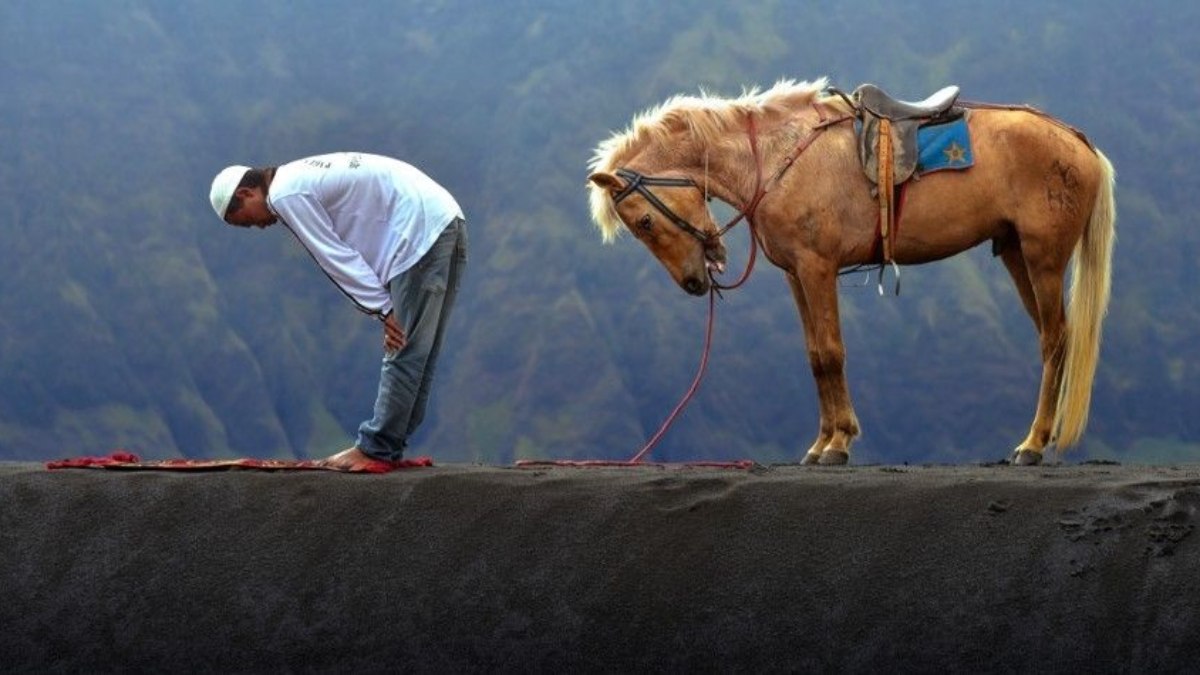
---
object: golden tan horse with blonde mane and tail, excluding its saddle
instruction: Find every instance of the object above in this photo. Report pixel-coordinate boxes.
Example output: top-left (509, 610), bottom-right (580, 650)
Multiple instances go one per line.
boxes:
top-left (588, 78), bottom-right (1115, 465)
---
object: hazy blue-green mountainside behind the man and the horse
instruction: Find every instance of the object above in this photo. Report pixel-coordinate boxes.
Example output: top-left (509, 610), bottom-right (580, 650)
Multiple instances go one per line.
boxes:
top-left (0, 0), bottom-right (1200, 464)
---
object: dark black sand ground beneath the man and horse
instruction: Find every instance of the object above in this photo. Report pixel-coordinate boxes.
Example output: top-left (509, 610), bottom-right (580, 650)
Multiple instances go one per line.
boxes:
top-left (0, 464), bottom-right (1200, 673)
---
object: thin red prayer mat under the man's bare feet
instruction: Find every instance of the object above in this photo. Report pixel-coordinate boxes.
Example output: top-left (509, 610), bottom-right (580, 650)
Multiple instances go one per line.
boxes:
top-left (46, 450), bottom-right (433, 473)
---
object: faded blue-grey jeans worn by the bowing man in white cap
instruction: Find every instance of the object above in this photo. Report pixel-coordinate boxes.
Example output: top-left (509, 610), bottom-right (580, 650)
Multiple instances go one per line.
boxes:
top-left (355, 219), bottom-right (467, 461)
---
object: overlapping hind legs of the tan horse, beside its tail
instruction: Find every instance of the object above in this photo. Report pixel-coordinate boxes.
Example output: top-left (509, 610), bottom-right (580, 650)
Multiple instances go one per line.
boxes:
top-left (1000, 237), bottom-right (1067, 465)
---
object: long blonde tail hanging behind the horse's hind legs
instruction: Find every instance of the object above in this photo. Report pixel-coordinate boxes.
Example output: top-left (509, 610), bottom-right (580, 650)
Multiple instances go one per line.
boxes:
top-left (1054, 150), bottom-right (1116, 450)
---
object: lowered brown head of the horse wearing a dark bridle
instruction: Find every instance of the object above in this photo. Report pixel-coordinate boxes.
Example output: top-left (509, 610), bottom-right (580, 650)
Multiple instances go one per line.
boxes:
top-left (588, 168), bottom-right (726, 295)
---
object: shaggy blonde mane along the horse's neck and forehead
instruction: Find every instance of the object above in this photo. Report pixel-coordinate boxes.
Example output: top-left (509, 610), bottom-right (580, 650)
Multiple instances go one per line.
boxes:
top-left (588, 77), bottom-right (829, 241)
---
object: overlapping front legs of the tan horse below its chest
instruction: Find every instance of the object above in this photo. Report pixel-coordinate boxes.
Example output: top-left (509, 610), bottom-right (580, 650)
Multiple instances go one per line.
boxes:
top-left (787, 268), bottom-right (858, 465)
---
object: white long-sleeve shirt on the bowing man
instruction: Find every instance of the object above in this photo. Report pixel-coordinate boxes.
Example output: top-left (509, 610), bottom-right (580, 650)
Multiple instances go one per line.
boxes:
top-left (268, 153), bottom-right (463, 315)
